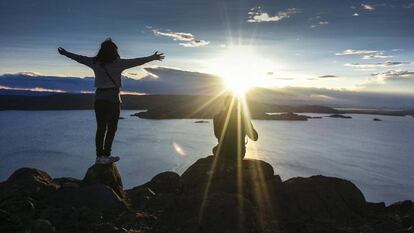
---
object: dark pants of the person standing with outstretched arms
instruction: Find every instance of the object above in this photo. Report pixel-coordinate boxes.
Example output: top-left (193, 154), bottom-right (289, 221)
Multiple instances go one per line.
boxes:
top-left (95, 100), bottom-right (121, 156)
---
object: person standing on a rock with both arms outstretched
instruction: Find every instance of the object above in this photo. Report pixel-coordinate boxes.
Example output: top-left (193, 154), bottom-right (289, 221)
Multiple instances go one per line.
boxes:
top-left (58, 38), bottom-right (164, 164)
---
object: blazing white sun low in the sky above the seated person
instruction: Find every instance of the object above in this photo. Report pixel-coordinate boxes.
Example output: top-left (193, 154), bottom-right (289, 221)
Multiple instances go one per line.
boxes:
top-left (207, 46), bottom-right (275, 95)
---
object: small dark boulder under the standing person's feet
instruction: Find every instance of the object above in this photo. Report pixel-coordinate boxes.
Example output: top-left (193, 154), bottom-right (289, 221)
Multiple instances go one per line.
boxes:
top-left (83, 163), bottom-right (124, 198)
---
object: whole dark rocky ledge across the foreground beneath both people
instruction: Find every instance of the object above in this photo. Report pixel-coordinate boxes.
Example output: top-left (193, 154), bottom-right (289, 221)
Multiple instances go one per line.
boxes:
top-left (0, 156), bottom-right (414, 233)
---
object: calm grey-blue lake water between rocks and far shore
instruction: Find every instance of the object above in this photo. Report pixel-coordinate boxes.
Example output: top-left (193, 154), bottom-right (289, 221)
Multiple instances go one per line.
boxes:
top-left (0, 111), bottom-right (414, 203)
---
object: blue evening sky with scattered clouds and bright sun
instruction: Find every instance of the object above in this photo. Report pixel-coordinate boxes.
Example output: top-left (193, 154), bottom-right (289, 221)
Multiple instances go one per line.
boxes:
top-left (0, 0), bottom-right (414, 97)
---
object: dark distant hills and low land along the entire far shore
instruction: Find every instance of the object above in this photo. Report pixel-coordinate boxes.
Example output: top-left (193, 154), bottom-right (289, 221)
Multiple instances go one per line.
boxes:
top-left (0, 93), bottom-right (414, 119)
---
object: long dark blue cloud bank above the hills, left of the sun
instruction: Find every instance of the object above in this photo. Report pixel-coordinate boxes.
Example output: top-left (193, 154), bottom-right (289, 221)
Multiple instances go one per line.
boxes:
top-left (0, 67), bottom-right (223, 95)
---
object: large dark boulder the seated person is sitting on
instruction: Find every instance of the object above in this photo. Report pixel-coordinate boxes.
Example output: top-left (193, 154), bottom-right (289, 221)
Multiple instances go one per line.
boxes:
top-left (181, 156), bottom-right (282, 216)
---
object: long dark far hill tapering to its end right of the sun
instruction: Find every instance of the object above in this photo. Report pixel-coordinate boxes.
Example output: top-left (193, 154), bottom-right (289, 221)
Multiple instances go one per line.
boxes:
top-left (0, 93), bottom-right (337, 114)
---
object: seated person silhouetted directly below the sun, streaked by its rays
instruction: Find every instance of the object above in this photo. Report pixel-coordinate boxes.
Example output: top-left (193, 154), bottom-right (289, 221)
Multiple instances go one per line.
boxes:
top-left (213, 96), bottom-right (258, 162)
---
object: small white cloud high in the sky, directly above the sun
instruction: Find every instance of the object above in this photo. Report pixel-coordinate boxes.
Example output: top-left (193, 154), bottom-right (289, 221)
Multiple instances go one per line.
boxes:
top-left (247, 7), bottom-right (300, 23)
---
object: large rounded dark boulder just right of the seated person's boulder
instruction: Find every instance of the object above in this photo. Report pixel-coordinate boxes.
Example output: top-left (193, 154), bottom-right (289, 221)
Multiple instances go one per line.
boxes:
top-left (282, 175), bottom-right (367, 227)
